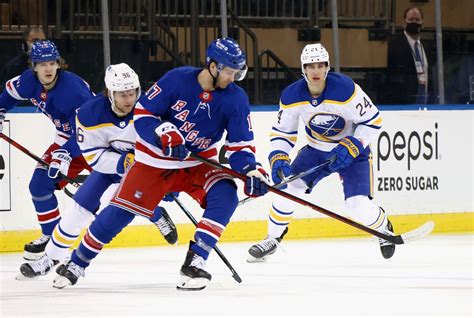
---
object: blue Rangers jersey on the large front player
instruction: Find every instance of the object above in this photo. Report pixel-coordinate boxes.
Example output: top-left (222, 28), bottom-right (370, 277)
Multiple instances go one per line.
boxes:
top-left (134, 67), bottom-right (255, 172)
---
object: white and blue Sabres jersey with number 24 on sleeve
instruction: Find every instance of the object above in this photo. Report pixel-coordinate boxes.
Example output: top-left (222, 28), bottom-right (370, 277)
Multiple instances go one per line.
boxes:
top-left (270, 73), bottom-right (382, 153)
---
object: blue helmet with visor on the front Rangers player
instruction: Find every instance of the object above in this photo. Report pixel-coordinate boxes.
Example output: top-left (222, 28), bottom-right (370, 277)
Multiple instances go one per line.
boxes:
top-left (206, 37), bottom-right (247, 81)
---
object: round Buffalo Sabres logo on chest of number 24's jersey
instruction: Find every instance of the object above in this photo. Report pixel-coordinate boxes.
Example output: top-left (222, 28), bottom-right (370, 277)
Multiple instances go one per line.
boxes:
top-left (306, 113), bottom-right (346, 140)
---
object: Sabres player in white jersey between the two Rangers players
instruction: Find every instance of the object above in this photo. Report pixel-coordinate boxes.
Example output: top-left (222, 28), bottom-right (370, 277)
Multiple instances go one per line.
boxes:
top-left (20, 63), bottom-right (178, 278)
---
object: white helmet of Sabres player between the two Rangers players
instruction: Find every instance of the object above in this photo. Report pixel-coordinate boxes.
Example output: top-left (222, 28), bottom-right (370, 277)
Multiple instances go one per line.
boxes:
top-left (104, 63), bottom-right (141, 115)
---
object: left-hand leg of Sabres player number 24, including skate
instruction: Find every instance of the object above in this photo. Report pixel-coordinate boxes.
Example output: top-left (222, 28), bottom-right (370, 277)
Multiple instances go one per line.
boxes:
top-left (247, 146), bottom-right (330, 262)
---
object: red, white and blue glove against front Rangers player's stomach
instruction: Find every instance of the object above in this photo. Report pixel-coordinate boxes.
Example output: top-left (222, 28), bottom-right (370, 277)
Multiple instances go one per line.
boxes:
top-left (155, 122), bottom-right (189, 161)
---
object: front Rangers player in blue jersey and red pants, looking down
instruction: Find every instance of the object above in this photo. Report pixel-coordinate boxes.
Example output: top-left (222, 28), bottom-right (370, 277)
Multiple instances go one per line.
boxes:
top-left (53, 38), bottom-right (268, 290)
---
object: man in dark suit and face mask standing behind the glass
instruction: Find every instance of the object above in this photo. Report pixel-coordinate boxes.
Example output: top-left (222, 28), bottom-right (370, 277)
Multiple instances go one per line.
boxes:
top-left (385, 7), bottom-right (432, 104)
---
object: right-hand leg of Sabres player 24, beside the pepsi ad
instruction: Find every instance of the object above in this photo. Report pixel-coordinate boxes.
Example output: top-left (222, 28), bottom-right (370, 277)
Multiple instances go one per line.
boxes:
top-left (340, 148), bottom-right (395, 258)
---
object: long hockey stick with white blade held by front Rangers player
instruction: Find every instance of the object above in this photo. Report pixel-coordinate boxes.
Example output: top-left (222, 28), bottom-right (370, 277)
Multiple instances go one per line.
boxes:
top-left (190, 153), bottom-right (434, 244)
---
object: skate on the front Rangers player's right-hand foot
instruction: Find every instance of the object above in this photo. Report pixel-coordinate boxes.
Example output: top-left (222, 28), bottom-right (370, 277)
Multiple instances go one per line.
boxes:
top-left (176, 249), bottom-right (212, 290)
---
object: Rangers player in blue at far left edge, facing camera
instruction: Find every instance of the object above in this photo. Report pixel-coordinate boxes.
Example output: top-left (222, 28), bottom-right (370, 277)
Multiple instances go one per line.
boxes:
top-left (0, 41), bottom-right (94, 260)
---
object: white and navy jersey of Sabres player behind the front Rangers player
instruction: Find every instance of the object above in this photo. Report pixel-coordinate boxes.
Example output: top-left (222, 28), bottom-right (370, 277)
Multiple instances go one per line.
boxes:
top-left (76, 95), bottom-right (137, 174)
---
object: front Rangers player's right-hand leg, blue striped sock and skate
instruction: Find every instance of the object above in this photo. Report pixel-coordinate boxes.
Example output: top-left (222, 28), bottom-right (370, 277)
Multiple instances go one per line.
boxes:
top-left (177, 169), bottom-right (239, 290)
